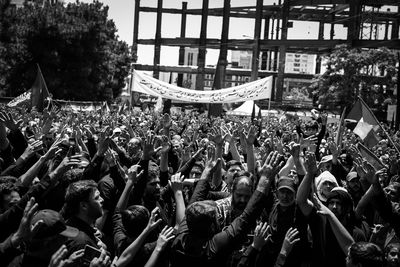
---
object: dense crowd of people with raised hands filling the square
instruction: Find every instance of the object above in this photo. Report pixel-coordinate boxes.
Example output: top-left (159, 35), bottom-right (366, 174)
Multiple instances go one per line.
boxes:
top-left (0, 107), bottom-right (400, 267)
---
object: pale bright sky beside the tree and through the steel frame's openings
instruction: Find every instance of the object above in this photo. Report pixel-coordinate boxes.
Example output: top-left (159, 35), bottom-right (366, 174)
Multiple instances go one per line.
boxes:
top-left (65, 0), bottom-right (396, 65)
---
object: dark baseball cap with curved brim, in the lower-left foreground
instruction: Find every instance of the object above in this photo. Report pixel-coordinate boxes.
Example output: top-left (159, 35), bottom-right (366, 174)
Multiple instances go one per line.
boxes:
top-left (32, 209), bottom-right (79, 239)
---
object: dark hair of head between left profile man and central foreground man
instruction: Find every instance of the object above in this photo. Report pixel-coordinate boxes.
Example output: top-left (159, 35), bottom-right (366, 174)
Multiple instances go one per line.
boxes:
top-left (121, 205), bottom-right (150, 238)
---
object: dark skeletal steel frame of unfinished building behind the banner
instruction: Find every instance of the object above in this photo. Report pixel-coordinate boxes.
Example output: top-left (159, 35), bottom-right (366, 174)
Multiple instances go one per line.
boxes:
top-left (132, 0), bottom-right (400, 107)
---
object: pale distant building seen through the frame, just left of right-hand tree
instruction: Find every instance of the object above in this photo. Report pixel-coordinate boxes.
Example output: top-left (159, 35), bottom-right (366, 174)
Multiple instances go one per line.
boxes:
top-left (285, 53), bottom-right (317, 74)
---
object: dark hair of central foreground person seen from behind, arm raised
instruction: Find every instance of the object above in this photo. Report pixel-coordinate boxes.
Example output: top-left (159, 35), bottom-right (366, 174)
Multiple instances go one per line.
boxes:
top-left (185, 200), bottom-right (219, 238)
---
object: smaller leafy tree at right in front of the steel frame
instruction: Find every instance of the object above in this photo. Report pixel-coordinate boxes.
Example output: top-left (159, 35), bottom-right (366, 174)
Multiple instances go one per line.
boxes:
top-left (313, 45), bottom-right (397, 109)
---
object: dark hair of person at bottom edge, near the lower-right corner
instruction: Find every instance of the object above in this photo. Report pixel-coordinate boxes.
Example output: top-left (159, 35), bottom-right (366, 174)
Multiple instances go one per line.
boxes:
top-left (349, 242), bottom-right (383, 267)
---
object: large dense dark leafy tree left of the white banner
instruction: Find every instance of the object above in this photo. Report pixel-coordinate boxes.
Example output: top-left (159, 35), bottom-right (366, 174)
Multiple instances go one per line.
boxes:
top-left (0, 0), bottom-right (132, 100)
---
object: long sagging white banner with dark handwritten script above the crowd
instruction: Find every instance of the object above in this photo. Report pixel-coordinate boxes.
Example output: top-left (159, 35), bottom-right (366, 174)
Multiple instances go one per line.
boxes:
top-left (132, 71), bottom-right (272, 103)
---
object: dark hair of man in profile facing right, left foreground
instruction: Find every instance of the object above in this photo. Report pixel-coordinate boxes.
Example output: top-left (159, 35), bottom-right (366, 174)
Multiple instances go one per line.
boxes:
top-left (63, 180), bottom-right (97, 218)
